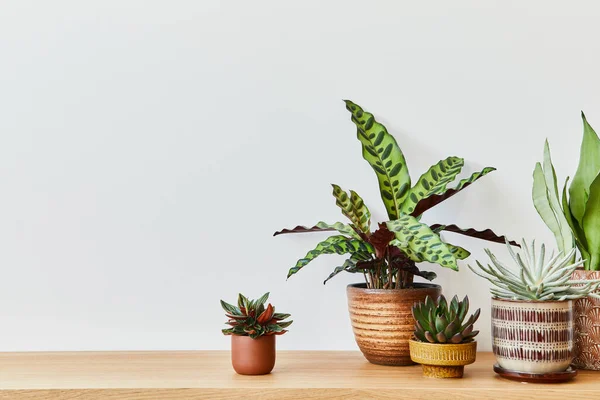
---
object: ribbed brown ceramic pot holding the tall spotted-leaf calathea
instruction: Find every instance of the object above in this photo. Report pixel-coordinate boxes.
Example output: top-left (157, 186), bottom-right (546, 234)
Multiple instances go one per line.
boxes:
top-left (346, 283), bottom-right (442, 365)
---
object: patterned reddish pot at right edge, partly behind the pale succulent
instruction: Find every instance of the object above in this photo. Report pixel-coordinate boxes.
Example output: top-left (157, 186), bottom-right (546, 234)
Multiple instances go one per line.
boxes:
top-left (573, 269), bottom-right (600, 371)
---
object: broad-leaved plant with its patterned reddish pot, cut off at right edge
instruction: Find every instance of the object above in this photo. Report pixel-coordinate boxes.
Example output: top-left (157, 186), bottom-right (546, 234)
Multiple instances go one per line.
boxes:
top-left (533, 113), bottom-right (600, 370)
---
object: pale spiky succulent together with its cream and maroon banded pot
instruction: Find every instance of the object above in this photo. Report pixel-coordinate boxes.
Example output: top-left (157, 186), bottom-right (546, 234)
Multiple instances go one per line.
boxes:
top-left (469, 241), bottom-right (598, 377)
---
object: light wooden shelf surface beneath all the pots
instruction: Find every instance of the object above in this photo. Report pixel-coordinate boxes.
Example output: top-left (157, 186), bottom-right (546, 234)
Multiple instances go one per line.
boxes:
top-left (0, 351), bottom-right (600, 400)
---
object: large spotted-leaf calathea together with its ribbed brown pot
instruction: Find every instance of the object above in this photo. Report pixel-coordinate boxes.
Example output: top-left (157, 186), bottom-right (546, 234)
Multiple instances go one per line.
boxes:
top-left (275, 100), bottom-right (516, 365)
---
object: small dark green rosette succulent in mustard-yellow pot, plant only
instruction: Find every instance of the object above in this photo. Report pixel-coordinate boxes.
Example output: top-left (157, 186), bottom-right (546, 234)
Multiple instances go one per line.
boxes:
top-left (412, 295), bottom-right (481, 344)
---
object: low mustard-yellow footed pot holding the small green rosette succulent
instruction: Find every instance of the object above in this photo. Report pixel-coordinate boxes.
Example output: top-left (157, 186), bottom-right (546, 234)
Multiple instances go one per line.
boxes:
top-left (409, 340), bottom-right (477, 378)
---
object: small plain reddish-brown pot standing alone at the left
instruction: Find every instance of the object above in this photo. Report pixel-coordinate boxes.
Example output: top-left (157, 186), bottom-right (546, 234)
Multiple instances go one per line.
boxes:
top-left (231, 335), bottom-right (275, 375)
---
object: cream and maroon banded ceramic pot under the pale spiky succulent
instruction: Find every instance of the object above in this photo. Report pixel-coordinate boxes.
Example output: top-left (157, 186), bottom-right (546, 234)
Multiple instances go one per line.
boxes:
top-left (492, 299), bottom-right (573, 374)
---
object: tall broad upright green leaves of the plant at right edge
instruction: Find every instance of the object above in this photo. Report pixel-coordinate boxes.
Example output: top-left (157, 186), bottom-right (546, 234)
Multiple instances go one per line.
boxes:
top-left (533, 112), bottom-right (600, 271)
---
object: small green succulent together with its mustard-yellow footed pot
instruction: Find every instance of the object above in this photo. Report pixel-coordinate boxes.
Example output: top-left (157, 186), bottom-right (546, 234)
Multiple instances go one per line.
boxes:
top-left (409, 296), bottom-right (481, 378)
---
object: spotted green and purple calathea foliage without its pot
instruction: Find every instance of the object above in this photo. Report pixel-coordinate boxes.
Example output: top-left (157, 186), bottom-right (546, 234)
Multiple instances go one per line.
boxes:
top-left (275, 100), bottom-right (516, 289)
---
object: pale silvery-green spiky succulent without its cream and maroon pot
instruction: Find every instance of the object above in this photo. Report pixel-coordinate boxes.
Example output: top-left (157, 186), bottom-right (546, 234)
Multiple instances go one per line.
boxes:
top-left (468, 240), bottom-right (600, 301)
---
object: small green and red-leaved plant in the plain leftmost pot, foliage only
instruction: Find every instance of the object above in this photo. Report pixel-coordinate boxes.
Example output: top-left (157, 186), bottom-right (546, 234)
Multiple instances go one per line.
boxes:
top-left (221, 293), bottom-right (293, 339)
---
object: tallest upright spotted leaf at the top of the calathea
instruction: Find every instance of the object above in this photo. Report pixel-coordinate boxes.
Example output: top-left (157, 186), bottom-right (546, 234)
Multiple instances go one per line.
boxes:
top-left (344, 100), bottom-right (410, 220)
